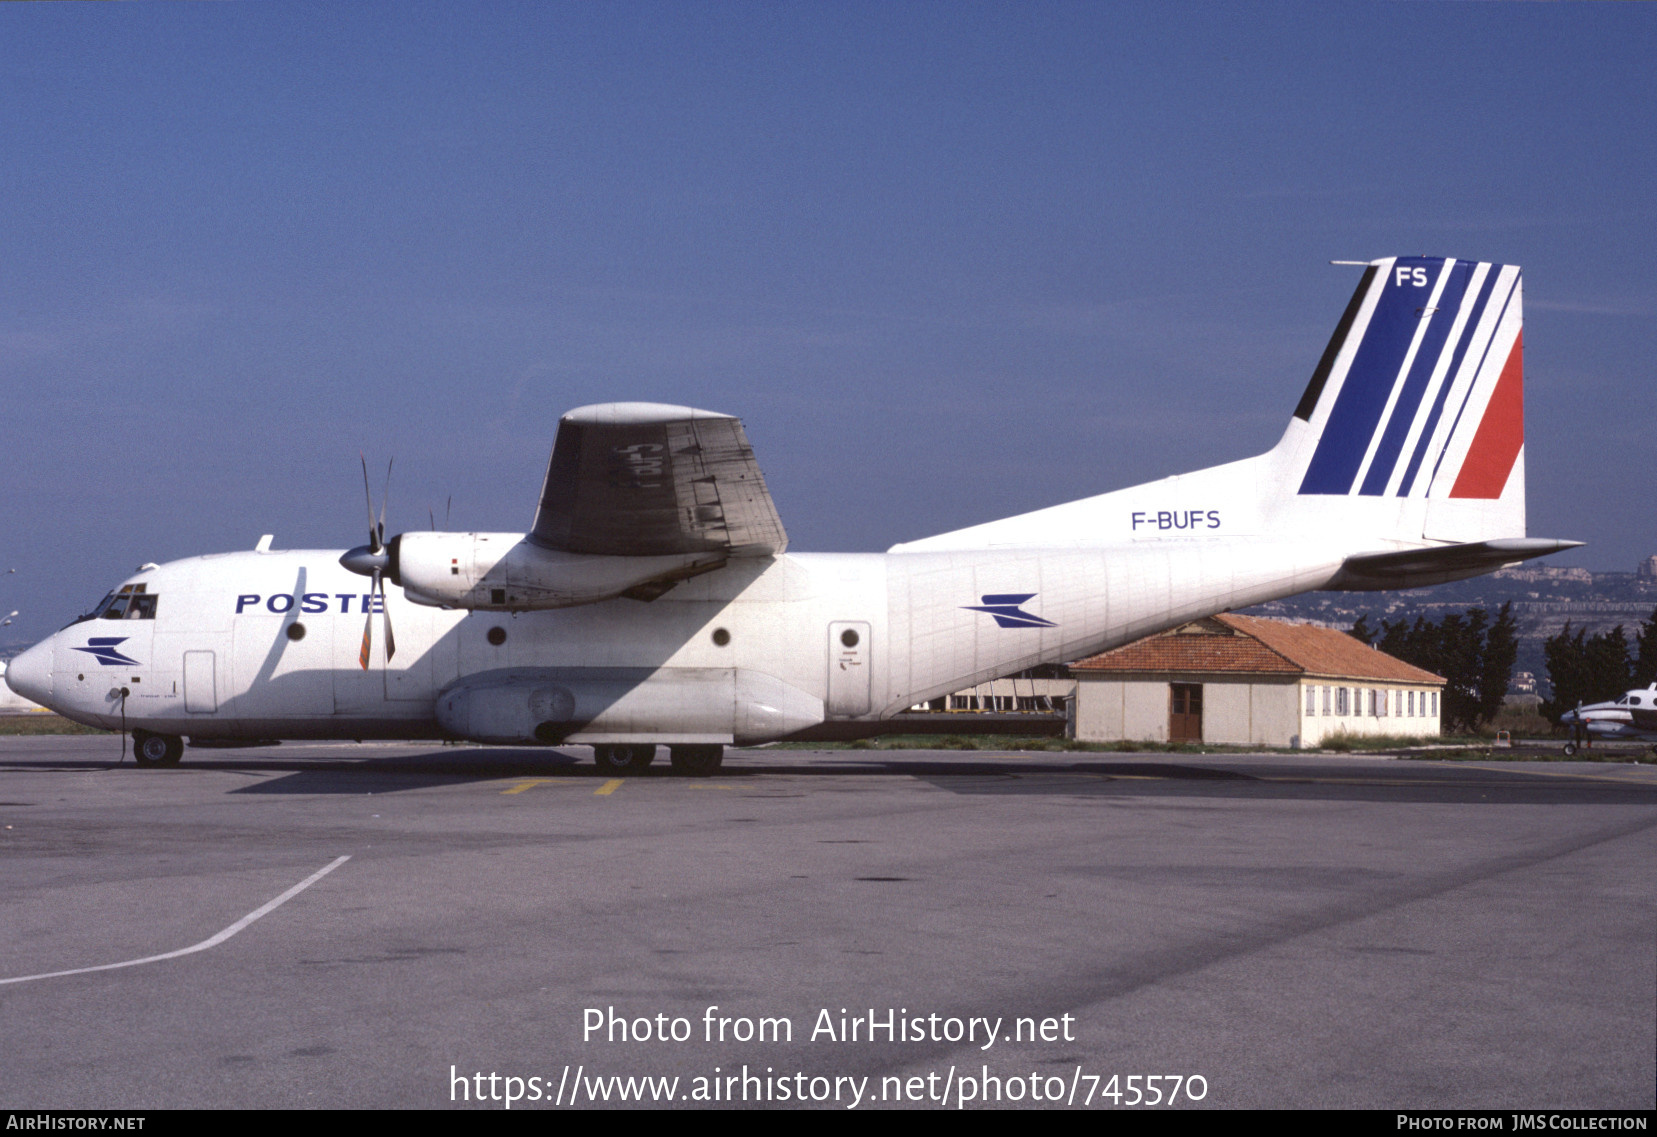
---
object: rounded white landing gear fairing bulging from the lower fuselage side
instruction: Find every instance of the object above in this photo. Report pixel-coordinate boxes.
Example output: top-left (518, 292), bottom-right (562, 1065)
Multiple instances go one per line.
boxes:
top-left (437, 668), bottom-right (824, 746)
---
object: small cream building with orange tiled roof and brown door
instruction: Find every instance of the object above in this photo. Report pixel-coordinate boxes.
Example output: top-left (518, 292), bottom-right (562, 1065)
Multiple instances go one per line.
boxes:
top-left (1070, 613), bottom-right (1445, 746)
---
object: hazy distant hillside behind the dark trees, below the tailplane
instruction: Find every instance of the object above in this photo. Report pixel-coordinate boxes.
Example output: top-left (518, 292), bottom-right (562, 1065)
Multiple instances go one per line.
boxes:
top-left (1243, 557), bottom-right (1657, 696)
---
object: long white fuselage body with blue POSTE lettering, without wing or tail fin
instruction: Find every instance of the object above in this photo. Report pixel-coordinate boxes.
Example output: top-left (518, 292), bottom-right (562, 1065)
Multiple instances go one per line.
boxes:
top-left (13, 537), bottom-right (1342, 743)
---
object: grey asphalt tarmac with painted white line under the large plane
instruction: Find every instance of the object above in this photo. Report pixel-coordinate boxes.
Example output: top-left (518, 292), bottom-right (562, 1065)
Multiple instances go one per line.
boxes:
top-left (0, 736), bottom-right (1657, 1112)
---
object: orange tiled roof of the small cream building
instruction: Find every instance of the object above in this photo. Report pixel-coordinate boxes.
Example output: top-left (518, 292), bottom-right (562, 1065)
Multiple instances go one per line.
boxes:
top-left (1070, 612), bottom-right (1443, 685)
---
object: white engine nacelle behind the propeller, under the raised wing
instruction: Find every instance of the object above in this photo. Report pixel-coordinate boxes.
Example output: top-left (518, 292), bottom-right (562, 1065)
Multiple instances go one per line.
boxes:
top-left (389, 530), bottom-right (726, 612)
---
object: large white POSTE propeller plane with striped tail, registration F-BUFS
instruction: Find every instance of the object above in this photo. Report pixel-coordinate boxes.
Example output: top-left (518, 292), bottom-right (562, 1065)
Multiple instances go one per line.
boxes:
top-left (7, 257), bottom-right (1579, 774)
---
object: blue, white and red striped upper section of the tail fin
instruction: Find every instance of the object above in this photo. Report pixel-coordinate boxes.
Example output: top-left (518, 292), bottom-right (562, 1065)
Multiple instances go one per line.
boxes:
top-left (1284, 257), bottom-right (1524, 513)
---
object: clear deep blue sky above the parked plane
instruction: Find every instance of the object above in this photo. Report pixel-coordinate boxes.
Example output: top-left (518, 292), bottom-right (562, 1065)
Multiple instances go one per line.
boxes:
top-left (0, 3), bottom-right (1657, 649)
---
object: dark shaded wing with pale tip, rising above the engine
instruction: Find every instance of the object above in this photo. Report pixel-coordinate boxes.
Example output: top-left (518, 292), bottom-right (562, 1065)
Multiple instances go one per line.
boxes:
top-left (530, 403), bottom-right (789, 557)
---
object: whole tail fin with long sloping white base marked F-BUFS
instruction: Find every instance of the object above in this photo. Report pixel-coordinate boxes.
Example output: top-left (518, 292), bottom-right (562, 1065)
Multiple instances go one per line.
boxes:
top-left (893, 257), bottom-right (1531, 560)
